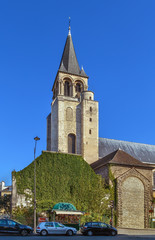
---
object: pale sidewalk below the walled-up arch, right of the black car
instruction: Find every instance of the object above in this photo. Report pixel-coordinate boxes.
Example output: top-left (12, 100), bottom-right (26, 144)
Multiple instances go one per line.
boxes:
top-left (117, 228), bottom-right (155, 235)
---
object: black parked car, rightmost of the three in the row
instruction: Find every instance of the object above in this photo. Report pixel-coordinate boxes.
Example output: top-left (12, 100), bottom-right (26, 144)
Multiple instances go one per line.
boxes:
top-left (80, 222), bottom-right (117, 236)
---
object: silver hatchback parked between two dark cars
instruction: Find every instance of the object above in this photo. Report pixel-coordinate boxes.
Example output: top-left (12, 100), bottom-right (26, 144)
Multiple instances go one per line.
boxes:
top-left (36, 222), bottom-right (77, 236)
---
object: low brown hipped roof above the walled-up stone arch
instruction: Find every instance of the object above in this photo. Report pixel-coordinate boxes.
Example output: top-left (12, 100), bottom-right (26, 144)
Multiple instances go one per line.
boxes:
top-left (91, 149), bottom-right (152, 169)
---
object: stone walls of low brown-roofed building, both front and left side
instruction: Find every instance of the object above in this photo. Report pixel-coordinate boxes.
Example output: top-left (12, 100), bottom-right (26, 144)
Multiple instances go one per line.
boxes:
top-left (92, 164), bottom-right (152, 229)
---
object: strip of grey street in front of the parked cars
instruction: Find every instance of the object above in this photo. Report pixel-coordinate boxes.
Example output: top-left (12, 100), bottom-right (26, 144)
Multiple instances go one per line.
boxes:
top-left (0, 234), bottom-right (155, 240)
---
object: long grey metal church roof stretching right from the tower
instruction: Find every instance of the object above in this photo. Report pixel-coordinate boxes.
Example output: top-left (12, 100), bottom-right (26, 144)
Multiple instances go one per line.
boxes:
top-left (99, 138), bottom-right (155, 164)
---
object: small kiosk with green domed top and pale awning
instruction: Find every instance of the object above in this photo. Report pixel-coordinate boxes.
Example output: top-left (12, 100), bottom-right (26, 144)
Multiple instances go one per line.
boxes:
top-left (52, 202), bottom-right (84, 230)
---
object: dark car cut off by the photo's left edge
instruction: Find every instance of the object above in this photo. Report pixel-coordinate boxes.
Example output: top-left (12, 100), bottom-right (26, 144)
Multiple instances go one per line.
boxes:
top-left (0, 219), bottom-right (33, 236)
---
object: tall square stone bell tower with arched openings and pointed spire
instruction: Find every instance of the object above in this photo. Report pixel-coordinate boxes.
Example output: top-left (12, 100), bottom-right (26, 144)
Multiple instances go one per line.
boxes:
top-left (47, 26), bottom-right (98, 164)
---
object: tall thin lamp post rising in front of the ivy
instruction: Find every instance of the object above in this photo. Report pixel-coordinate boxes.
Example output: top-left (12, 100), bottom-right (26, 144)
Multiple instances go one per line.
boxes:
top-left (34, 137), bottom-right (40, 233)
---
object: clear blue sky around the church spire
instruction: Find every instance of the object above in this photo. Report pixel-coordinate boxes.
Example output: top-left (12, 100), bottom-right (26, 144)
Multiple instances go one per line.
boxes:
top-left (0, 0), bottom-right (155, 184)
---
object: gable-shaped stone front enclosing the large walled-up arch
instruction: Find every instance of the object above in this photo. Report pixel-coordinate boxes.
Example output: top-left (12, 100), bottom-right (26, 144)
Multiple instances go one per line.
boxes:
top-left (115, 167), bottom-right (152, 228)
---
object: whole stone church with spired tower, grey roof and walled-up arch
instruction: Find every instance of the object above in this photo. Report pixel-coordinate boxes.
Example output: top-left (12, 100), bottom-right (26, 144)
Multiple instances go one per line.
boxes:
top-left (47, 24), bottom-right (155, 228)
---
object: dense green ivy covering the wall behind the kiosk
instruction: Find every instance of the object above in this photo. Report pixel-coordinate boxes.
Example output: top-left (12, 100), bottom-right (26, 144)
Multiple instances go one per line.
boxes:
top-left (13, 152), bottom-right (110, 215)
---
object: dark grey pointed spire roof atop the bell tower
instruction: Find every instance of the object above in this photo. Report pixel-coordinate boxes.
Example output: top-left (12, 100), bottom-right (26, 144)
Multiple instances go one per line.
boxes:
top-left (59, 30), bottom-right (88, 77)
